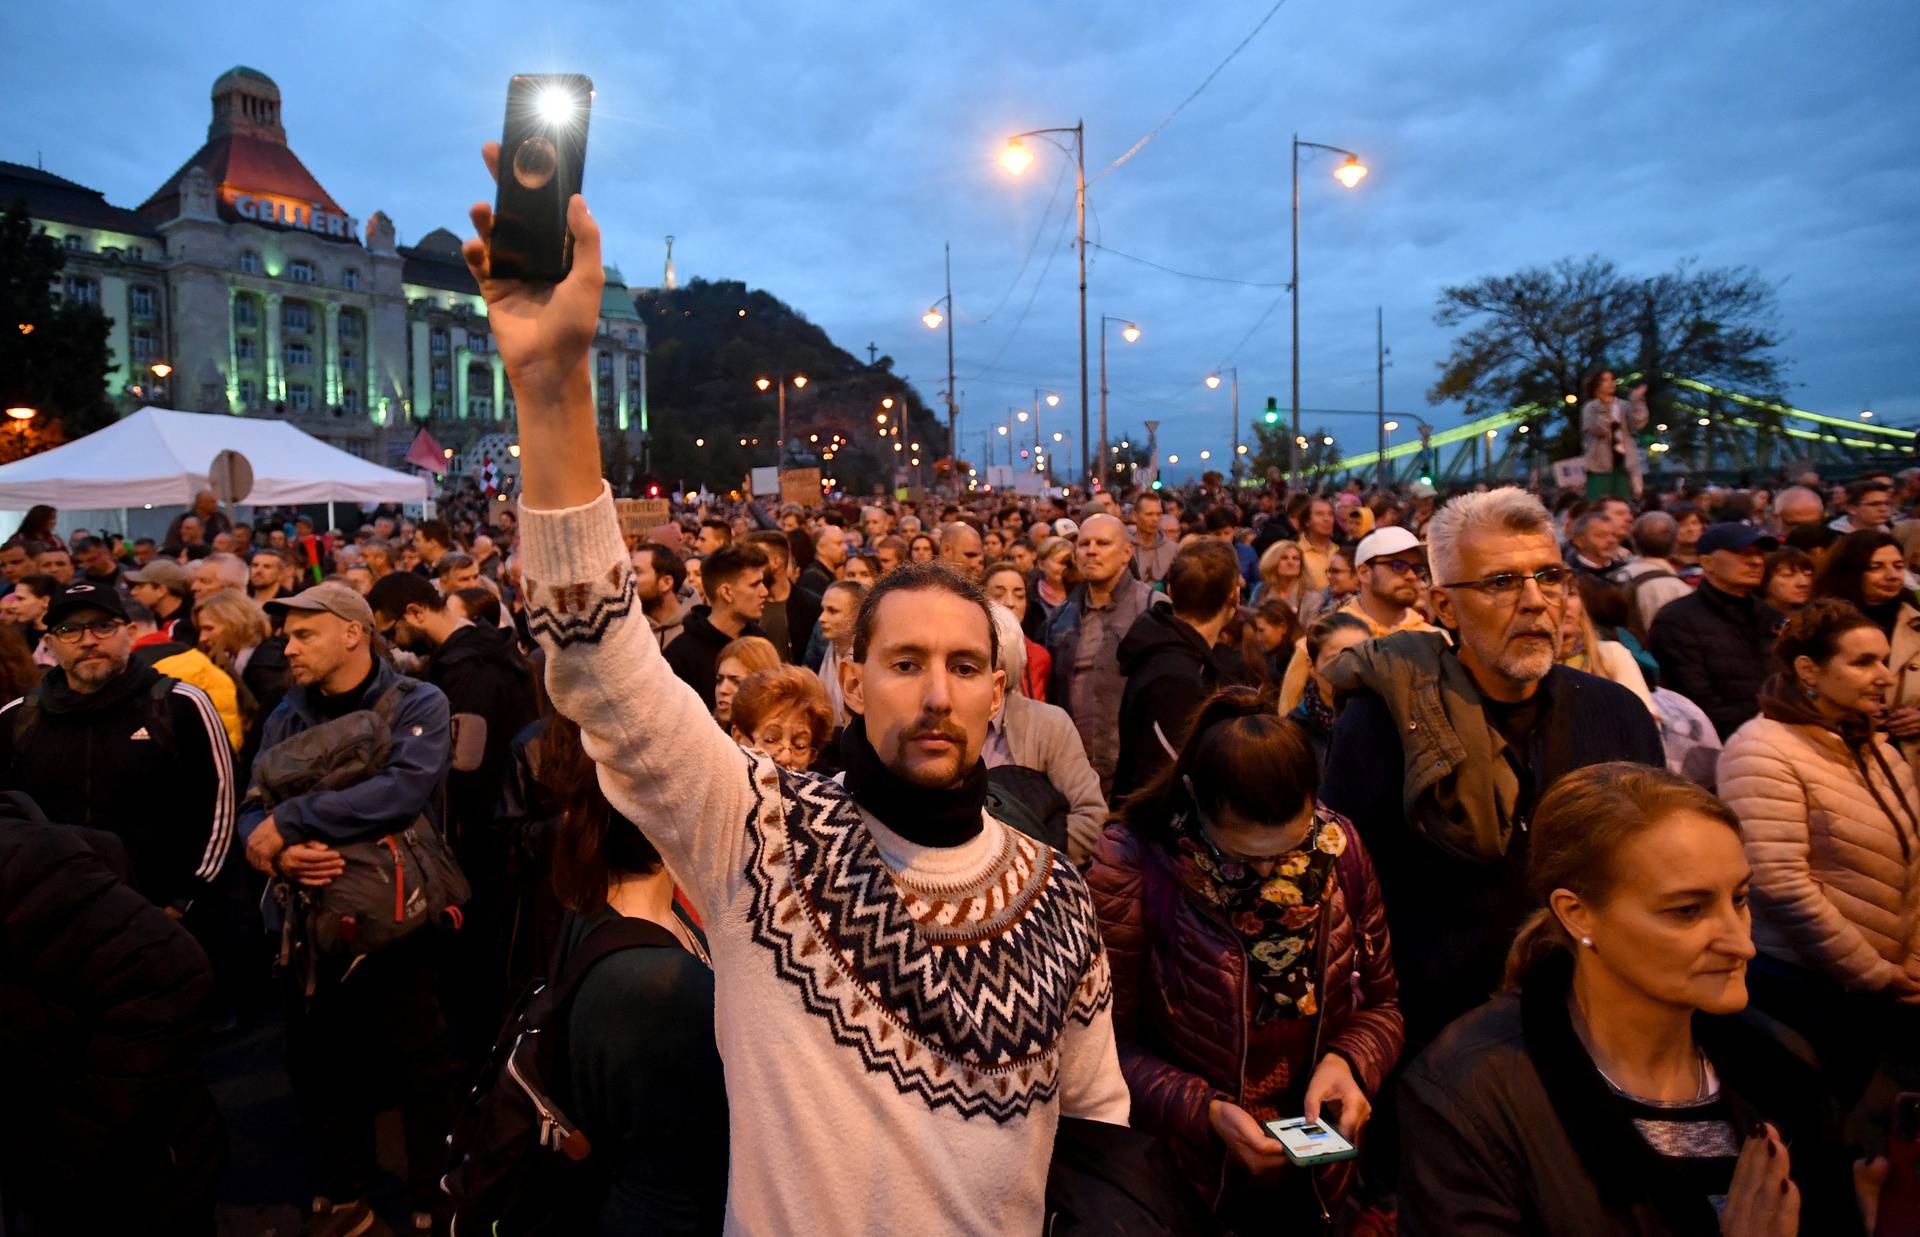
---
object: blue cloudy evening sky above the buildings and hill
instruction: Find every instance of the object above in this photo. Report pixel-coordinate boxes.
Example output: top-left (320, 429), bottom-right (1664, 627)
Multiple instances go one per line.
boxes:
top-left (0, 0), bottom-right (1920, 478)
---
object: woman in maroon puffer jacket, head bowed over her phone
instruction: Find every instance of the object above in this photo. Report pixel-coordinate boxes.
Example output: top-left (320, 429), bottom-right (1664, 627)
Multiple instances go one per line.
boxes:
top-left (1087, 688), bottom-right (1405, 1233)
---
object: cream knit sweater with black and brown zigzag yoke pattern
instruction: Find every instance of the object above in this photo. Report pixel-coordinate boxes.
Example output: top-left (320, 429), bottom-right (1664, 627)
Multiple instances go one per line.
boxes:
top-left (520, 492), bottom-right (1127, 1233)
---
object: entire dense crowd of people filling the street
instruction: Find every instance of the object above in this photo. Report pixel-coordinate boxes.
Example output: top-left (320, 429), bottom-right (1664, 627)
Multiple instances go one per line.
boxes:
top-left (0, 159), bottom-right (1920, 1237)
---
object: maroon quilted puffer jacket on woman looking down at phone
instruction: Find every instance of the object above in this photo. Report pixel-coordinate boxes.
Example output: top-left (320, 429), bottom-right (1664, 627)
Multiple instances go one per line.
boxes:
top-left (1087, 810), bottom-right (1405, 1204)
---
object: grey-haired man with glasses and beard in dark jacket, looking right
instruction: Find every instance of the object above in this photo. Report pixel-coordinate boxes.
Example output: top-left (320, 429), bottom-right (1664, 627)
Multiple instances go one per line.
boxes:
top-left (1321, 486), bottom-right (1663, 1060)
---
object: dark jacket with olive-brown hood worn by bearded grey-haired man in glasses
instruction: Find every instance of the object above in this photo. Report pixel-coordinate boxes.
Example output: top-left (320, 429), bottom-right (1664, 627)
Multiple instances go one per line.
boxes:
top-left (1321, 632), bottom-right (1665, 1043)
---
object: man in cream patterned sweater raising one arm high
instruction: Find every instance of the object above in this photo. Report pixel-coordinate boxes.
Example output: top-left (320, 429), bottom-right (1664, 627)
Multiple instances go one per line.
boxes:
top-left (465, 144), bottom-right (1127, 1233)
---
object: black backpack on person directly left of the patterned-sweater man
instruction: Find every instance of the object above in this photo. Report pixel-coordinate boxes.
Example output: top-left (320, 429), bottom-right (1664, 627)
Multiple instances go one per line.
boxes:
top-left (440, 916), bottom-right (680, 1237)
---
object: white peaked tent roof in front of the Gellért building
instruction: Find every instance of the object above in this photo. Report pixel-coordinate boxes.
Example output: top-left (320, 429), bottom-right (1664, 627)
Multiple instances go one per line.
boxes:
top-left (0, 407), bottom-right (428, 511)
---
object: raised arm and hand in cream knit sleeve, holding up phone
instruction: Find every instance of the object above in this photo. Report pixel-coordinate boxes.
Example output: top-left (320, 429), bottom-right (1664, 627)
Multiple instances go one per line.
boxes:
top-left (463, 142), bottom-right (764, 902)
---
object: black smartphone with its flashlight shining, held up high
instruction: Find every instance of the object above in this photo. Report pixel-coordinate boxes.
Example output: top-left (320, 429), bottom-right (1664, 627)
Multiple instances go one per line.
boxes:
top-left (488, 73), bottom-right (593, 284)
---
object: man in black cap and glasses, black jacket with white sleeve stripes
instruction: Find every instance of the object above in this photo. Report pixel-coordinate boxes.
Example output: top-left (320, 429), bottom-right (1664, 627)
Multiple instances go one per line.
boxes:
top-left (0, 580), bottom-right (234, 926)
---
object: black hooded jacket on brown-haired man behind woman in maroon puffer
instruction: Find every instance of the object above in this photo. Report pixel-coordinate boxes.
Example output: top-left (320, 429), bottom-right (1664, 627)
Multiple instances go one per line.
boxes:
top-left (1114, 605), bottom-right (1219, 799)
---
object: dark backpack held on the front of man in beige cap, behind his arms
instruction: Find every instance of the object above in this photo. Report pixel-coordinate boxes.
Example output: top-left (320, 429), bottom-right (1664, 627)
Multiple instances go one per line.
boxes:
top-left (248, 678), bottom-right (472, 956)
